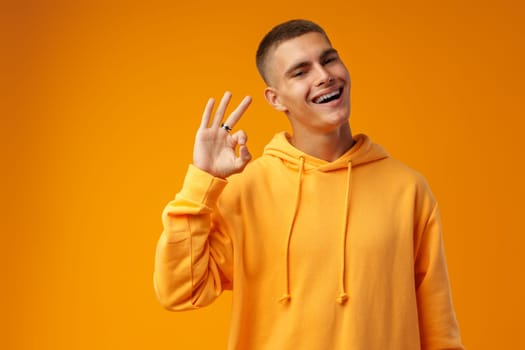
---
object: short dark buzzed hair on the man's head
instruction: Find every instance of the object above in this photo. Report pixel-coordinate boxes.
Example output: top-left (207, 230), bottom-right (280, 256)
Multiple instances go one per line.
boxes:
top-left (255, 19), bottom-right (330, 84)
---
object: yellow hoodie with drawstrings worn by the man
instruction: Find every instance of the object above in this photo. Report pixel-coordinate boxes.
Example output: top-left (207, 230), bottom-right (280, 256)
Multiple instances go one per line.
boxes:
top-left (154, 133), bottom-right (463, 350)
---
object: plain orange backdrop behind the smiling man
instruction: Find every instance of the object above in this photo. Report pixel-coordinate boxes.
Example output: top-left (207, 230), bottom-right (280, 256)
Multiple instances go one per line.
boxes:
top-left (0, 0), bottom-right (525, 350)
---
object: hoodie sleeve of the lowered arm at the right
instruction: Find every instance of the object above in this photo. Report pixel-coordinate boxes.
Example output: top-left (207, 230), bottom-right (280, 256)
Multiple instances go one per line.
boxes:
top-left (415, 203), bottom-right (464, 350)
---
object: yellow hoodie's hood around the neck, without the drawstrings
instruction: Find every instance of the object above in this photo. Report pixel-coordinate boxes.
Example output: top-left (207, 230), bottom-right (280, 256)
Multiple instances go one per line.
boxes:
top-left (264, 132), bottom-right (389, 172)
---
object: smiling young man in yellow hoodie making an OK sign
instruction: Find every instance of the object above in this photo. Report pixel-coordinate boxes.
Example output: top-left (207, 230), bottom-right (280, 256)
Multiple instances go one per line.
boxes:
top-left (155, 20), bottom-right (463, 350)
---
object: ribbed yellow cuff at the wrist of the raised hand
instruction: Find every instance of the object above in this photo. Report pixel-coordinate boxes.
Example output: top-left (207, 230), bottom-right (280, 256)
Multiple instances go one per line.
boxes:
top-left (179, 164), bottom-right (228, 207)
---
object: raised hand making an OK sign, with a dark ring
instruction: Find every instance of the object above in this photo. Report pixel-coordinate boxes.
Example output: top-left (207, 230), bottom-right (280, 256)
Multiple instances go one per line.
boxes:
top-left (193, 92), bottom-right (252, 178)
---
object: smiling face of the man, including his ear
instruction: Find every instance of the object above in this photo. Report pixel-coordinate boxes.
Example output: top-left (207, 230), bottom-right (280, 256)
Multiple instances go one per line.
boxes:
top-left (265, 32), bottom-right (350, 133)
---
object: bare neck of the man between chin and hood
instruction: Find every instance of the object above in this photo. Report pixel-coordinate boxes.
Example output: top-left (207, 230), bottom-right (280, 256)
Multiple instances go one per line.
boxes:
top-left (290, 123), bottom-right (355, 162)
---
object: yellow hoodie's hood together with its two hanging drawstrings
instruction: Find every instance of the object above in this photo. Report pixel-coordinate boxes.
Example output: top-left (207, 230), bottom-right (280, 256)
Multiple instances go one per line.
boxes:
top-left (263, 132), bottom-right (389, 305)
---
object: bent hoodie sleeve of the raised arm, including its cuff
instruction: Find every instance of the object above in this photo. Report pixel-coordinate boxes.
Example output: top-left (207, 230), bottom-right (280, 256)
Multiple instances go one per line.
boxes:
top-left (154, 165), bottom-right (233, 311)
